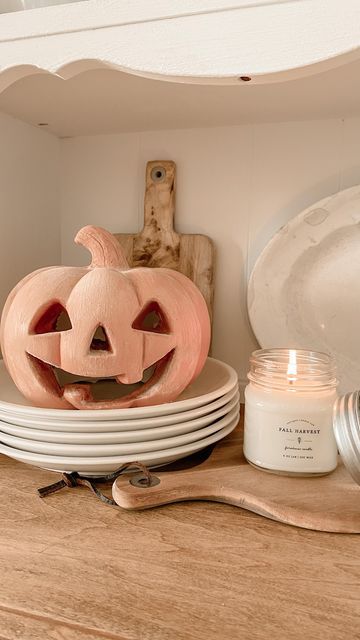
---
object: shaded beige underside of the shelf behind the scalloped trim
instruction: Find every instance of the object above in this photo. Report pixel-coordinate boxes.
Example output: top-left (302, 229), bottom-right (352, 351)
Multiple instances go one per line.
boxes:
top-left (0, 61), bottom-right (360, 137)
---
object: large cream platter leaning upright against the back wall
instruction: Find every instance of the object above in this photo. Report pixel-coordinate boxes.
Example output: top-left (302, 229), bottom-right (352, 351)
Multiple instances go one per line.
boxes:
top-left (248, 186), bottom-right (360, 393)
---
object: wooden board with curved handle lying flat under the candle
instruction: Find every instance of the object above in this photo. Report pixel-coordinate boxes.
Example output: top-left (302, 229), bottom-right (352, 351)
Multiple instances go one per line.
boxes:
top-left (113, 434), bottom-right (360, 533)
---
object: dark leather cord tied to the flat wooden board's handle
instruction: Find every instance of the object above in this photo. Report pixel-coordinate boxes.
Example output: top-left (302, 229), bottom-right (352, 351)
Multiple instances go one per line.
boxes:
top-left (37, 462), bottom-right (152, 506)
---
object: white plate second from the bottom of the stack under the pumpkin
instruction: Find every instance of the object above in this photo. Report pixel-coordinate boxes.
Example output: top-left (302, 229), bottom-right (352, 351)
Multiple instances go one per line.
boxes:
top-left (0, 403), bottom-right (240, 457)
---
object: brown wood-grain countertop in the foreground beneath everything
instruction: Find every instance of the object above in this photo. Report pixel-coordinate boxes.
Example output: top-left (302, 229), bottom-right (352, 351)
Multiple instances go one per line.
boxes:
top-left (0, 412), bottom-right (360, 640)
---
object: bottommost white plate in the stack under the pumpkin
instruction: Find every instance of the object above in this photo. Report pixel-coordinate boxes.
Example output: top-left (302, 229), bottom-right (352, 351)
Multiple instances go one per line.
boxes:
top-left (0, 416), bottom-right (238, 476)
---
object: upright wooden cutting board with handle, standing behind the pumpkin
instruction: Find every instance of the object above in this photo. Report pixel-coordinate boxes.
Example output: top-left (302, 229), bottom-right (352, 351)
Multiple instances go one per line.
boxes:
top-left (115, 160), bottom-right (214, 318)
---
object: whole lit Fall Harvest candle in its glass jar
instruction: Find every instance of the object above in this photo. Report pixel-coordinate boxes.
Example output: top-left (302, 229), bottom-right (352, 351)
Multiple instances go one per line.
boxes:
top-left (244, 349), bottom-right (337, 476)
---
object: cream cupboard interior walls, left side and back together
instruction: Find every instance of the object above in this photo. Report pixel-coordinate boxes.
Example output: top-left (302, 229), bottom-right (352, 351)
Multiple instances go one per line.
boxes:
top-left (0, 114), bottom-right (360, 379)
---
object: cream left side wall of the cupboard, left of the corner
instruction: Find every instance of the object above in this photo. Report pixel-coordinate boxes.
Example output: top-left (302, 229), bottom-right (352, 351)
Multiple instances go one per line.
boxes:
top-left (0, 113), bottom-right (60, 309)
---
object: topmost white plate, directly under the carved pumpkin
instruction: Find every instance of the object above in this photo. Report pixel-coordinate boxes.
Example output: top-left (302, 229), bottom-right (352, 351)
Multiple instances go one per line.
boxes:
top-left (0, 358), bottom-right (238, 422)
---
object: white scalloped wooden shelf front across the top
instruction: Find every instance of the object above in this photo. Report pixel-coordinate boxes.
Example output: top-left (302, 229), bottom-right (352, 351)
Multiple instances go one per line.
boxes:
top-left (0, 0), bottom-right (360, 90)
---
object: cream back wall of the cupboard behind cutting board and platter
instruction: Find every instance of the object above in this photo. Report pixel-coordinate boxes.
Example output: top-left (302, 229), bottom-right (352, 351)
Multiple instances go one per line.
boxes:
top-left (61, 119), bottom-right (360, 388)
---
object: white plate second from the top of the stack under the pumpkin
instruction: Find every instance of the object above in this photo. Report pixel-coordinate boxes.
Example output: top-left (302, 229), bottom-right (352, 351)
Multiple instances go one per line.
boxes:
top-left (0, 383), bottom-right (238, 432)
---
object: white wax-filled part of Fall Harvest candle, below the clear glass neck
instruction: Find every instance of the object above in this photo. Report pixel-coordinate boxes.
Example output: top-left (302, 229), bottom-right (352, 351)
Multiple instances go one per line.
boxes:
top-left (244, 384), bottom-right (337, 473)
